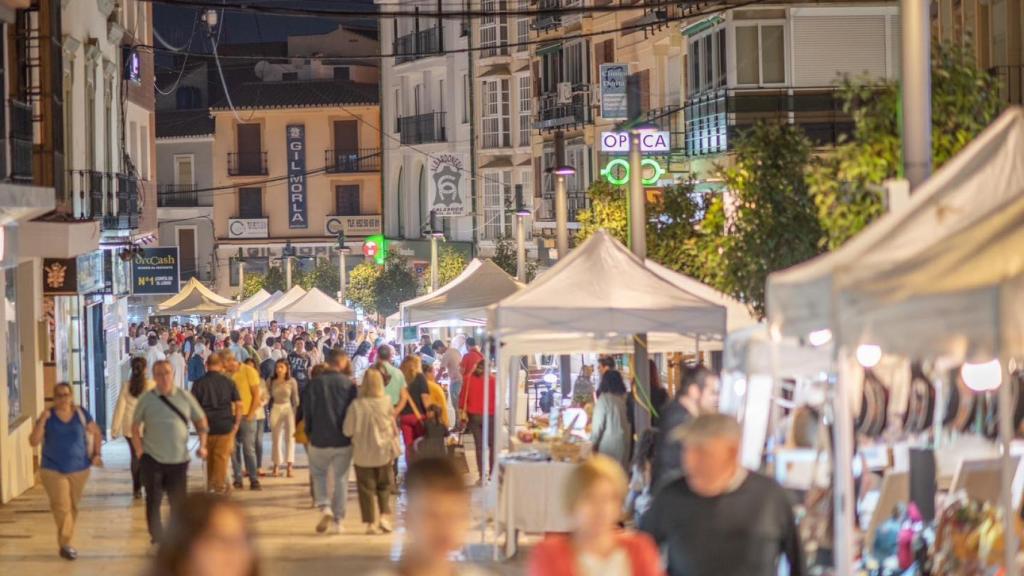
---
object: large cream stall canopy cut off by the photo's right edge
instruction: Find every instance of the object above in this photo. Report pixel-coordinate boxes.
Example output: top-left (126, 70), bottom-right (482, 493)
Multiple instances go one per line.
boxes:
top-left (767, 108), bottom-right (1024, 358)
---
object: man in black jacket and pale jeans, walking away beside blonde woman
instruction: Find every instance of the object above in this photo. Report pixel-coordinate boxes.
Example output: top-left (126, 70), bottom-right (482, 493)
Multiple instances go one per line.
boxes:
top-left (301, 348), bottom-right (355, 534)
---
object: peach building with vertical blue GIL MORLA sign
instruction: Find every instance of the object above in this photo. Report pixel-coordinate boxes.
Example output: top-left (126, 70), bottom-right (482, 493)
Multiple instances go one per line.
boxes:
top-left (210, 54), bottom-right (382, 295)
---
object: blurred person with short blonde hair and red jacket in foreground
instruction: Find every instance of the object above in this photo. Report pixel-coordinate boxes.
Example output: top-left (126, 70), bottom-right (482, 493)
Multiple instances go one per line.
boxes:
top-left (527, 454), bottom-right (665, 576)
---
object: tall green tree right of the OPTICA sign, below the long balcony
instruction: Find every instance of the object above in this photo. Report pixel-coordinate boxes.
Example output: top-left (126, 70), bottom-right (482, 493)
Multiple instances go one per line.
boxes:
top-left (720, 123), bottom-right (821, 317)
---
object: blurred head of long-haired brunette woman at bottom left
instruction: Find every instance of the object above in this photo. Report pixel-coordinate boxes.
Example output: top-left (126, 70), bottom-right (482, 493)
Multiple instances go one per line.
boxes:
top-left (148, 494), bottom-right (259, 576)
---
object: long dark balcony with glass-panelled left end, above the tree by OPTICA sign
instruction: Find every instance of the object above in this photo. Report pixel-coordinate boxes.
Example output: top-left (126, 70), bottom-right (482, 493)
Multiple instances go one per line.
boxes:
top-left (683, 88), bottom-right (853, 157)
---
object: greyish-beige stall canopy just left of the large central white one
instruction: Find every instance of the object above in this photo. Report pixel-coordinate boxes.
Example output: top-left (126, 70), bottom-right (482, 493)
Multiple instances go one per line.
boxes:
top-left (400, 258), bottom-right (523, 325)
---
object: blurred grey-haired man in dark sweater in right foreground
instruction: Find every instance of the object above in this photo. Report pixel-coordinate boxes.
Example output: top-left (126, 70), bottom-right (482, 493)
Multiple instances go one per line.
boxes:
top-left (640, 414), bottom-right (806, 576)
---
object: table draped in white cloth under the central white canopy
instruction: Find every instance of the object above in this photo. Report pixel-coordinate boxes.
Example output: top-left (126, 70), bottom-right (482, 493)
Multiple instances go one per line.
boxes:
top-left (498, 460), bottom-right (577, 558)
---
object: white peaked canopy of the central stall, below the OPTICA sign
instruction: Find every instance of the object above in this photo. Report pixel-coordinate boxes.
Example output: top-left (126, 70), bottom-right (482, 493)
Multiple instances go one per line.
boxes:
top-left (488, 231), bottom-right (726, 354)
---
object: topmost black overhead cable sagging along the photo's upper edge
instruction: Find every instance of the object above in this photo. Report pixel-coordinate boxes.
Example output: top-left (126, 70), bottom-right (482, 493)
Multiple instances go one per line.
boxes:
top-left (141, 0), bottom-right (712, 19)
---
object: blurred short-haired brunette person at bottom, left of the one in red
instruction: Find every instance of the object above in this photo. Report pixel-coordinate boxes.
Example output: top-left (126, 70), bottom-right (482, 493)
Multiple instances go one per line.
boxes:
top-left (375, 458), bottom-right (491, 576)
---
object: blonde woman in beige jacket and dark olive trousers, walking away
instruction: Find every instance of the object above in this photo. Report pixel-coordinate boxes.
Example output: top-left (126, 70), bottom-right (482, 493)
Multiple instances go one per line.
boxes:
top-left (342, 368), bottom-right (401, 534)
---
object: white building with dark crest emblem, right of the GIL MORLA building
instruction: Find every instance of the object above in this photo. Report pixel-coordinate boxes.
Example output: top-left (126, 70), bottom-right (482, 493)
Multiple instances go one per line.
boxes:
top-left (379, 1), bottom-right (475, 264)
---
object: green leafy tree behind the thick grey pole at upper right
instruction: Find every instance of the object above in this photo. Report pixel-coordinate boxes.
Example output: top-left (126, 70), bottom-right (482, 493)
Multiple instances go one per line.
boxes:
top-left (807, 43), bottom-right (1002, 250)
